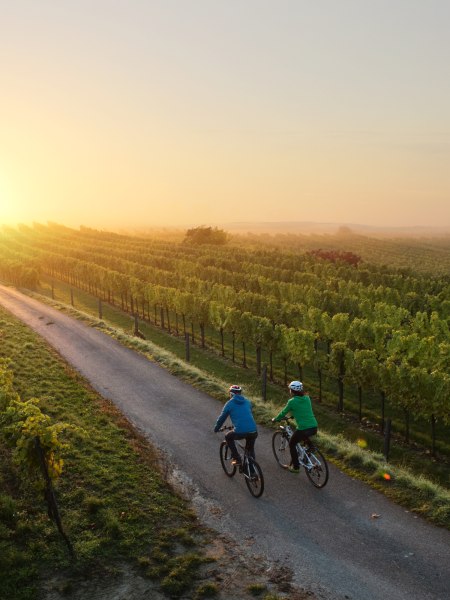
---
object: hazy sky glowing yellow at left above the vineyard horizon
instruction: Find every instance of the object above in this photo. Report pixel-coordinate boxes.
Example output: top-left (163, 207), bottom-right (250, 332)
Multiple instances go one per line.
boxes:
top-left (0, 0), bottom-right (450, 228)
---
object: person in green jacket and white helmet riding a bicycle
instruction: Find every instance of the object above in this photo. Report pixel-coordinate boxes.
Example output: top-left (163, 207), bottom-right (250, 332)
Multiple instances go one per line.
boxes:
top-left (272, 381), bottom-right (317, 473)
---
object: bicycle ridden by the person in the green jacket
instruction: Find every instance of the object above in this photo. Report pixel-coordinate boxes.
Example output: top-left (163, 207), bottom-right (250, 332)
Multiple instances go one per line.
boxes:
top-left (272, 417), bottom-right (329, 488)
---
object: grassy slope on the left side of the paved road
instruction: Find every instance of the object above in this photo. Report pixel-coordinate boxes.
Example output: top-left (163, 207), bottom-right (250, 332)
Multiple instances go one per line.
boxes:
top-left (0, 309), bottom-right (218, 600)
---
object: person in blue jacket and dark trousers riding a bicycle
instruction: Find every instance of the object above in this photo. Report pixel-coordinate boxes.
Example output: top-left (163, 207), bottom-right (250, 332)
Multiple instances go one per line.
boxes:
top-left (214, 385), bottom-right (258, 465)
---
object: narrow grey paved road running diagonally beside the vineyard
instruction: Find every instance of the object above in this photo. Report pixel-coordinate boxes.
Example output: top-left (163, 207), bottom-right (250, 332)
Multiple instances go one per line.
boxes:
top-left (0, 286), bottom-right (450, 600)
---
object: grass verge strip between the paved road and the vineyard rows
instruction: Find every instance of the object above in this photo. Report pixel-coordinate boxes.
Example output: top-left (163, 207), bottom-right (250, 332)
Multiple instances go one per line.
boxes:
top-left (24, 282), bottom-right (450, 528)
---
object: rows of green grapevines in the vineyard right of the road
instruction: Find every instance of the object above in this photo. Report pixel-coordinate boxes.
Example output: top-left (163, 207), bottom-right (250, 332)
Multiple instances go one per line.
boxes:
top-left (0, 226), bottom-right (450, 456)
